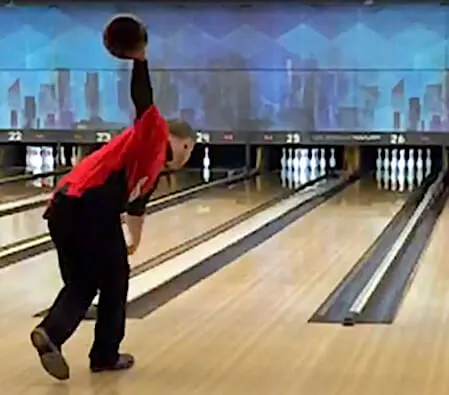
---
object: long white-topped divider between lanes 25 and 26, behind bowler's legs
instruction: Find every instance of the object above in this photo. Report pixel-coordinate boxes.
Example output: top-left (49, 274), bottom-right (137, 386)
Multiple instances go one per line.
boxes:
top-left (34, 174), bottom-right (352, 319)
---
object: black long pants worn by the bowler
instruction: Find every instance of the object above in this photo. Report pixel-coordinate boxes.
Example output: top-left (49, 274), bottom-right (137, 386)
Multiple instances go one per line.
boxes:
top-left (40, 195), bottom-right (130, 364)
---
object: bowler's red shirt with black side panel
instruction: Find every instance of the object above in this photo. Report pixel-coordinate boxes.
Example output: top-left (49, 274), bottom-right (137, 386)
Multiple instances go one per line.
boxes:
top-left (50, 105), bottom-right (169, 215)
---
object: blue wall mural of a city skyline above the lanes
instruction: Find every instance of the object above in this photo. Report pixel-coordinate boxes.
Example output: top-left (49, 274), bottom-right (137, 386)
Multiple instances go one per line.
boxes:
top-left (0, 3), bottom-right (449, 131)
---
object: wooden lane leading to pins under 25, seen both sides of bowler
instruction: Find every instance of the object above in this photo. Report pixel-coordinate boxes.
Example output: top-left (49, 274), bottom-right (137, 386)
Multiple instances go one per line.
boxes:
top-left (0, 176), bottom-right (280, 320)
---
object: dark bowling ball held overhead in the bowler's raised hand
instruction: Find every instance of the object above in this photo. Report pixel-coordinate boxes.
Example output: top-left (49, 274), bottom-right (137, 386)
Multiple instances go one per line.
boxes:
top-left (103, 15), bottom-right (148, 59)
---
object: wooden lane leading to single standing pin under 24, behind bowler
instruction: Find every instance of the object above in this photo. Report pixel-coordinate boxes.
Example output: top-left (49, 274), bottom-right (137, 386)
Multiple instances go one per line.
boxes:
top-left (0, 172), bottom-right (201, 247)
